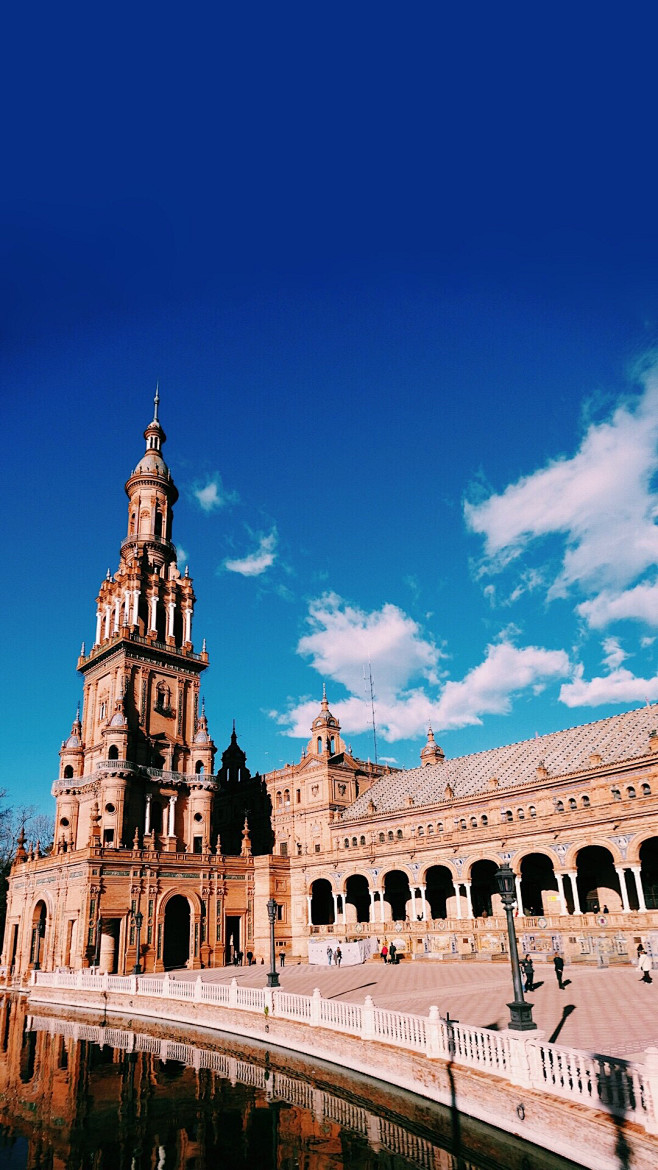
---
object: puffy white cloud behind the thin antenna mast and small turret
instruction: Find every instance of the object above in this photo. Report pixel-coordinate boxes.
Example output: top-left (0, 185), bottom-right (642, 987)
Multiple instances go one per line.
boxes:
top-left (273, 594), bottom-right (570, 742)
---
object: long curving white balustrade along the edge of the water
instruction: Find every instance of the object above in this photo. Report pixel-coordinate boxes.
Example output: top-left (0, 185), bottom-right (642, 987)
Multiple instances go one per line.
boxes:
top-left (32, 970), bottom-right (658, 1133)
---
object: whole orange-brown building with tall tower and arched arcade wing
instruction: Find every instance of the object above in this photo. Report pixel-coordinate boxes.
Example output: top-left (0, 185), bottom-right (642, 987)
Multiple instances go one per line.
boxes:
top-left (2, 395), bottom-right (658, 977)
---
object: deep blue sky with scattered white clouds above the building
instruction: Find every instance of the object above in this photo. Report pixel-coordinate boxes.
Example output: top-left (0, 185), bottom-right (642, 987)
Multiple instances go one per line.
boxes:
top-left (0, 5), bottom-right (658, 807)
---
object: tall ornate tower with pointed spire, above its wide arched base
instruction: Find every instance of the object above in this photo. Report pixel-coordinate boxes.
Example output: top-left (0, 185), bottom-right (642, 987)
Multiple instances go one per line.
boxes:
top-left (54, 393), bottom-right (214, 852)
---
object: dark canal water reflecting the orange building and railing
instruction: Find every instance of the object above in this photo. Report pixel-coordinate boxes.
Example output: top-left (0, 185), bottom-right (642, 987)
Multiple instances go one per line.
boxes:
top-left (0, 996), bottom-right (573, 1170)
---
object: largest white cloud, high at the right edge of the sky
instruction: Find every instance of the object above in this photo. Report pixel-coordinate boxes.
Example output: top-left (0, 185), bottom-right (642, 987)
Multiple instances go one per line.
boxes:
top-left (465, 370), bottom-right (658, 597)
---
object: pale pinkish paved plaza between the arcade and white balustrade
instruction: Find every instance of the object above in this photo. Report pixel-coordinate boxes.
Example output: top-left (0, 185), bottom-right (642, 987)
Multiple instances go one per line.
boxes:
top-left (172, 959), bottom-right (658, 1060)
